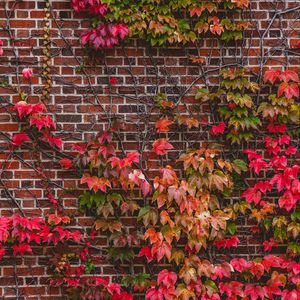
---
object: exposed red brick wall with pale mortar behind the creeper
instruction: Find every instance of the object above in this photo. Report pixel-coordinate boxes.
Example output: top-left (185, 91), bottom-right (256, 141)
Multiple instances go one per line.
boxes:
top-left (0, 0), bottom-right (300, 299)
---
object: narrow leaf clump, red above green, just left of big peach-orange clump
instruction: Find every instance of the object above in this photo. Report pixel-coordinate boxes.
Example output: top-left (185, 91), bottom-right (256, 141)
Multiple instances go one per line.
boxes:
top-left (74, 132), bottom-right (150, 262)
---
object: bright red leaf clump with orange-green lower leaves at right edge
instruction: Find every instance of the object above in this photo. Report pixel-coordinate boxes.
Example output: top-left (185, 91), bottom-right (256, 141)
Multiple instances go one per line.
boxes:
top-left (242, 126), bottom-right (300, 255)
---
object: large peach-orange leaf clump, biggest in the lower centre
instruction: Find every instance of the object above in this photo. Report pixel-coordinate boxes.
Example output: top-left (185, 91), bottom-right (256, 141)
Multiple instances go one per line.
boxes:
top-left (140, 144), bottom-right (246, 265)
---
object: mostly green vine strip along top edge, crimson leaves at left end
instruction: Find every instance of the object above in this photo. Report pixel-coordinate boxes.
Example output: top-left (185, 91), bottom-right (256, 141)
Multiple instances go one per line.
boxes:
top-left (72, 0), bottom-right (249, 49)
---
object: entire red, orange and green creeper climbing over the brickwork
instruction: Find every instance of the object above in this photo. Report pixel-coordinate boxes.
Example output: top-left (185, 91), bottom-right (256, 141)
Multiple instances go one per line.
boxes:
top-left (0, 0), bottom-right (300, 300)
